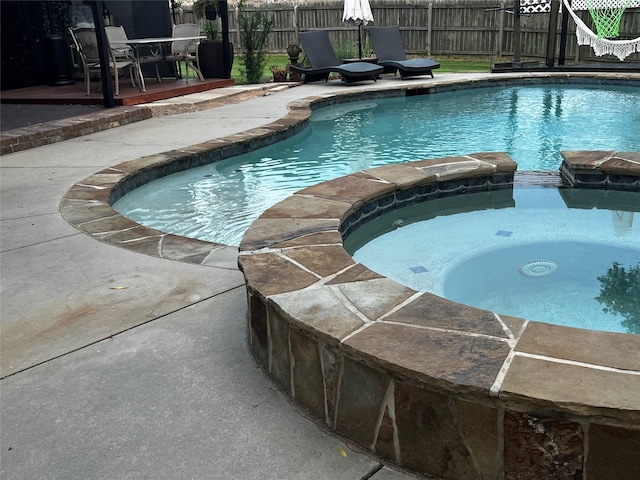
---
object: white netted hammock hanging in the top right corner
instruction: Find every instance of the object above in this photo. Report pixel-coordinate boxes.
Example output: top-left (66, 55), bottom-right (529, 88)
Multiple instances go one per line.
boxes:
top-left (563, 0), bottom-right (640, 61)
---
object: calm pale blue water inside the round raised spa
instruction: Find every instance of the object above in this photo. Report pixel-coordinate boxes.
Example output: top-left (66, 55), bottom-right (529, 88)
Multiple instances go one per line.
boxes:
top-left (345, 188), bottom-right (640, 333)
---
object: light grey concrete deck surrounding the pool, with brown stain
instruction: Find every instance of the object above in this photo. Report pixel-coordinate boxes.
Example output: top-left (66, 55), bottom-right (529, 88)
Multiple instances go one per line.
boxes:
top-left (0, 74), bottom-right (636, 480)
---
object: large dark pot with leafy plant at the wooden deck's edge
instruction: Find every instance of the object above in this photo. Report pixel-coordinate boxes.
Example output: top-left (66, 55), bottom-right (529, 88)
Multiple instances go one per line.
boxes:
top-left (193, 0), bottom-right (234, 78)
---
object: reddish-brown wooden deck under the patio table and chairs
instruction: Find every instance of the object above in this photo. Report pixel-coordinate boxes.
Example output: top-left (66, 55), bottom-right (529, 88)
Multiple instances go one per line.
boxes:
top-left (0, 78), bottom-right (234, 106)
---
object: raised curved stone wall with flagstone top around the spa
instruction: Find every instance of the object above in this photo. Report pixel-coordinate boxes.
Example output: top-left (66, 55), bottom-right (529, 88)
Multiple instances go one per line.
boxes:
top-left (239, 152), bottom-right (640, 480)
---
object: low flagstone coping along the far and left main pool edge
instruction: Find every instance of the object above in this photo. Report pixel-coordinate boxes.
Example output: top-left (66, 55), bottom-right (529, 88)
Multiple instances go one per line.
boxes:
top-left (60, 72), bottom-right (640, 267)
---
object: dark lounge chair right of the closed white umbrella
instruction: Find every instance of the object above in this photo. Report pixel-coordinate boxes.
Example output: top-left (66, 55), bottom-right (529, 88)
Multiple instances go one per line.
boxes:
top-left (368, 27), bottom-right (440, 80)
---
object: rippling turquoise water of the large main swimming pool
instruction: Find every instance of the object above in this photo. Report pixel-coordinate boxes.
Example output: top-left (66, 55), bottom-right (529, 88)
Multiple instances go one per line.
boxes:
top-left (113, 85), bottom-right (640, 245)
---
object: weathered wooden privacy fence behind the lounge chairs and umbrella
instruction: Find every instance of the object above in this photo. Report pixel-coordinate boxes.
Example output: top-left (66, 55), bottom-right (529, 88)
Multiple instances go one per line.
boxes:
top-left (181, 0), bottom-right (640, 63)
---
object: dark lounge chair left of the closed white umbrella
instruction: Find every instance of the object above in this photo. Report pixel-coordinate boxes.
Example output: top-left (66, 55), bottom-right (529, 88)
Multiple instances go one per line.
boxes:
top-left (289, 30), bottom-right (384, 84)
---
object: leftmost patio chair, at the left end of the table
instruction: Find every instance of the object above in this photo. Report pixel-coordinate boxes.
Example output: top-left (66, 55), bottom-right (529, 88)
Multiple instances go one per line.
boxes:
top-left (69, 28), bottom-right (136, 95)
